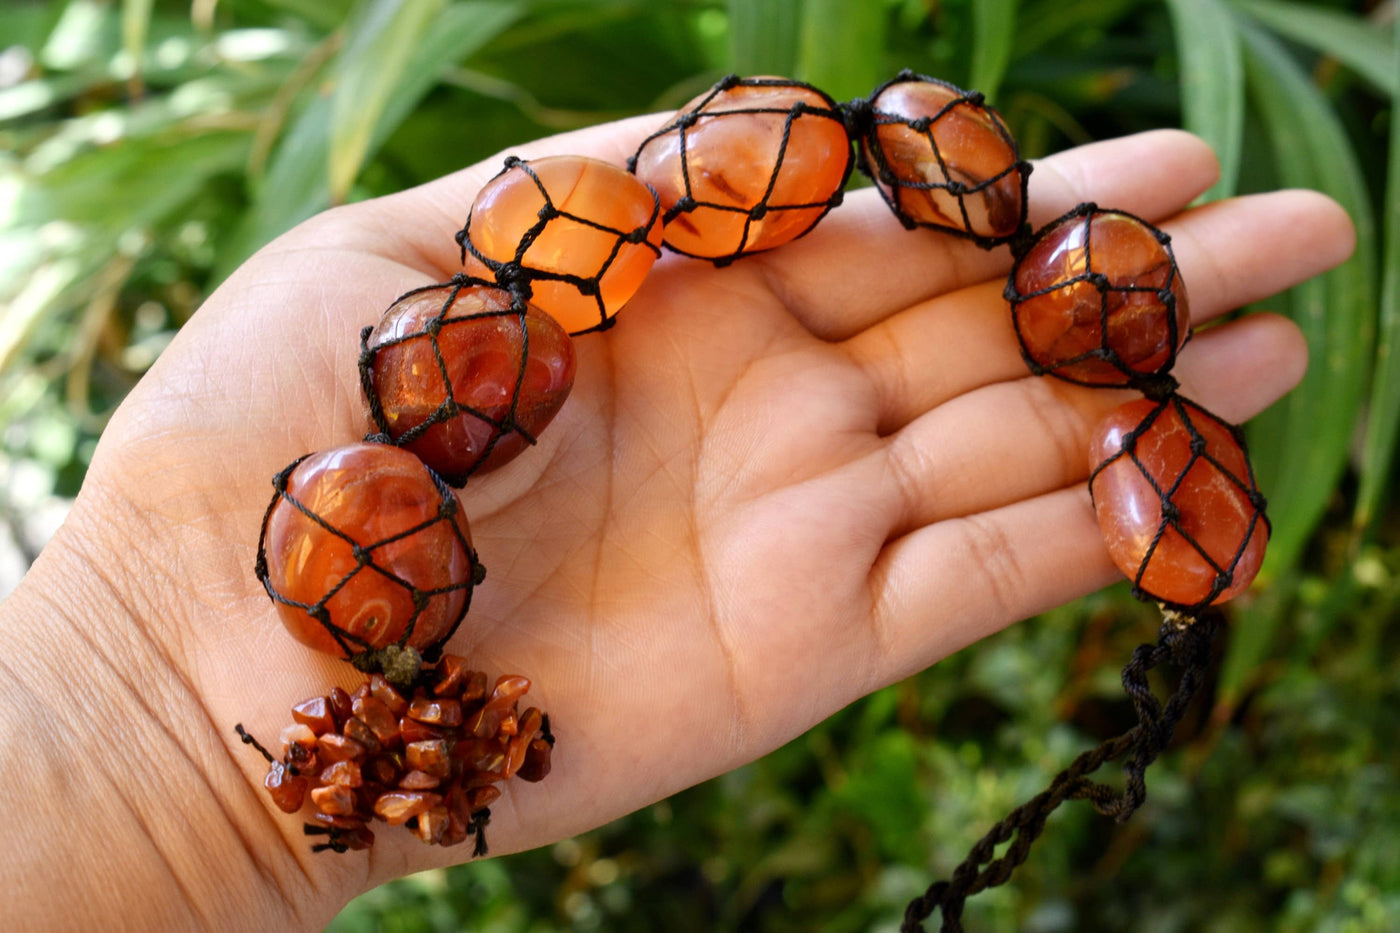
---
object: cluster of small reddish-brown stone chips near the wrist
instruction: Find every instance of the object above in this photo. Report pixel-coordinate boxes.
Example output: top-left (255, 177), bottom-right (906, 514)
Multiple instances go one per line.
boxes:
top-left (254, 654), bottom-right (554, 855)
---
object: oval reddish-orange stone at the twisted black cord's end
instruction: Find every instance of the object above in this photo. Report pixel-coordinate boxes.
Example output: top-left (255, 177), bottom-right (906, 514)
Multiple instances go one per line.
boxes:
top-left (1089, 396), bottom-right (1268, 605)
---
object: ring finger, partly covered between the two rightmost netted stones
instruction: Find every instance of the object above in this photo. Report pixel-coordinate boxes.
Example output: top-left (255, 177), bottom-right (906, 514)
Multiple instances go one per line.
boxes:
top-left (872, 314), bottom-right (1308, 537)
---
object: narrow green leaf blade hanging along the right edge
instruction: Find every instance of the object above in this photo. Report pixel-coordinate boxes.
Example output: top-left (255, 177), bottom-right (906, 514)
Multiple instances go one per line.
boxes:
top-left (1355, 20), bottom-right (1400, 530)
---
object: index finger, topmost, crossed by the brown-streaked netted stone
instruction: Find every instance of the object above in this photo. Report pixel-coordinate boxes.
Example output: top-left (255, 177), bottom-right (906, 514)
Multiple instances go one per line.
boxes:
top-left (749, 130), bottom-right (1219, 340)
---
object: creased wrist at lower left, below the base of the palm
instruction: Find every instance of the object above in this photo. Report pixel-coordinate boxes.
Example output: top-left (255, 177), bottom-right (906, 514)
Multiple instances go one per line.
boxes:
top-left (0, 493), bottom-right (354, 930)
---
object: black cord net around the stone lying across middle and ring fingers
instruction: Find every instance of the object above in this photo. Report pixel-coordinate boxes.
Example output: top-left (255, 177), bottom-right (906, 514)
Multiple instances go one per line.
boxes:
top-left (1005, 202), bottom-right (1190, 389)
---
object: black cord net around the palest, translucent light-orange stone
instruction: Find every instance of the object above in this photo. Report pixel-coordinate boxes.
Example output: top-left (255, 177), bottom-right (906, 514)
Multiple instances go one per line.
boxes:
top-left (456, 156), bottom-right (661, 336)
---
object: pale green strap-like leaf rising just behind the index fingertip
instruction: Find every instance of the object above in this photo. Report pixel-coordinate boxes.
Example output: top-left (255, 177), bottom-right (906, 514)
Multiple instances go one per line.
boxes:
top-left (1168, 0), bottom-right (1245, 200)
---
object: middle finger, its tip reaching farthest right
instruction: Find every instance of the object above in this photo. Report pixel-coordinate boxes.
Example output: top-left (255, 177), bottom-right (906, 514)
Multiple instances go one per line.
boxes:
top-left (841, 191), bottom-right (1355, 433)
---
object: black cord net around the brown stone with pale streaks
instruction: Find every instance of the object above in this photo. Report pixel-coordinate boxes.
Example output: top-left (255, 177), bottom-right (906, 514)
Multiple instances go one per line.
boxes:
top-left (841, 69), bottom-right (1033, 249)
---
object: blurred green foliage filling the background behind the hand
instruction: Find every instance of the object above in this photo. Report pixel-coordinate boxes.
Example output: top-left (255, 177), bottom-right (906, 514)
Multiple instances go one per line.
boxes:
top-left (0, 0), bottom-right (1400, 933)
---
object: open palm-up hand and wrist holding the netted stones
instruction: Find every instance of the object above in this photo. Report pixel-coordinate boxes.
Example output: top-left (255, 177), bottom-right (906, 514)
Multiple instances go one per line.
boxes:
top-left (0, 118), bottom-right (1352, 930)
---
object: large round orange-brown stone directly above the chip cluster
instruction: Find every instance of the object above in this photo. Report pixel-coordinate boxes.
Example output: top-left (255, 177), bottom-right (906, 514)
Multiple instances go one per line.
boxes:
top-left (263, 444), bottom-right (475, 652)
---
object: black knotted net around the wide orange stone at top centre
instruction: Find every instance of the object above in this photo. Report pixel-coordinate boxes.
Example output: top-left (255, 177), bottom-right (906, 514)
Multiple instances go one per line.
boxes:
top-left (627, 74), bottom-right (853, 266)
